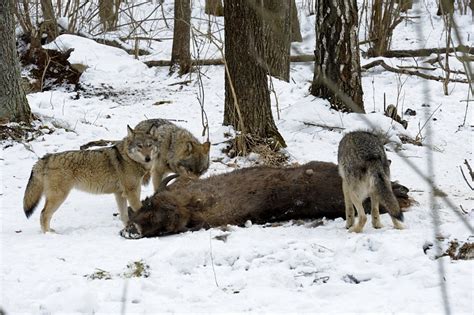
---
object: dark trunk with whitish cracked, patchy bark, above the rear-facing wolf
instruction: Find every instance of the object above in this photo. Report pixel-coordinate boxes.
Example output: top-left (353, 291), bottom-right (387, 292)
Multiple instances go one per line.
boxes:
top-left (311, 0), bottom-right (364, 112)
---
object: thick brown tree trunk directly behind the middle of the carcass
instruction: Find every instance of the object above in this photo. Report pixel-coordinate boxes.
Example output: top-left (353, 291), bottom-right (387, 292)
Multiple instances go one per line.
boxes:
top-left (224, 0), bottom-right (285, 146)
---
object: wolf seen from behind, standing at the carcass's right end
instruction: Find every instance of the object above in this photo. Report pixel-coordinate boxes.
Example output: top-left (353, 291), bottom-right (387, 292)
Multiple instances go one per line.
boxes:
top-left (337, 131), bottom-right (403, 233)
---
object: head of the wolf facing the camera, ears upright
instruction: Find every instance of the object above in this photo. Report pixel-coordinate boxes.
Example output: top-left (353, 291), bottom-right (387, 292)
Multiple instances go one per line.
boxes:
top-left (125, 126), bottom-right (158, 167)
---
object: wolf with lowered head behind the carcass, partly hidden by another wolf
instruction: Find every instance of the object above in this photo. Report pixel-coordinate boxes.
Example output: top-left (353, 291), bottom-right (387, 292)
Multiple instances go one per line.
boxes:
top-left (81, 119), bottom-right (210, 191)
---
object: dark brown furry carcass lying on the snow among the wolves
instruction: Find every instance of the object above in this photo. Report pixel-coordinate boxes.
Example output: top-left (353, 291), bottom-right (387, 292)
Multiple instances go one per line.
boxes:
top-left (121, 161), bottom-right (410, 238)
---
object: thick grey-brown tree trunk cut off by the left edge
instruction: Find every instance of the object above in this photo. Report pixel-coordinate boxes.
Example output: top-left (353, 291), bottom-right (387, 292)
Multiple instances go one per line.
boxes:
top-left (0, 0), bottom-right (32, 123)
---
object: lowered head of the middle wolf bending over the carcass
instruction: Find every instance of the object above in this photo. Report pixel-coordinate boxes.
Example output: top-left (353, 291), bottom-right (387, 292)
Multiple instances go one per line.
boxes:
top-left (168, 134), bottom-right (211, 176)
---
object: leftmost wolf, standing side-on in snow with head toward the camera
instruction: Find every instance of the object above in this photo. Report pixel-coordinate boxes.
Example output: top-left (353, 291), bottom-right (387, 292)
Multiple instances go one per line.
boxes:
top-left (23, 126), bottom-right (158, 232)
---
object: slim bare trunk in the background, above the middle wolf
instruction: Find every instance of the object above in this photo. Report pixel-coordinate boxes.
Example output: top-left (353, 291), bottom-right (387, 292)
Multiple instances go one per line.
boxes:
top-left (170, 0), bottom-right (191, 75)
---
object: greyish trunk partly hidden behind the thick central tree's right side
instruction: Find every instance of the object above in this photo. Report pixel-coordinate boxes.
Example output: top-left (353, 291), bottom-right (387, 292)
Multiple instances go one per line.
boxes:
top-left (262, 0), bottom-right (291, 82)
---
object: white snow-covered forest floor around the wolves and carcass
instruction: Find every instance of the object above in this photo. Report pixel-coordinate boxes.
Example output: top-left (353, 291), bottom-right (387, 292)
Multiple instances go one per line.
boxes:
top-left (0, 1), bottom-right (474, 314)
